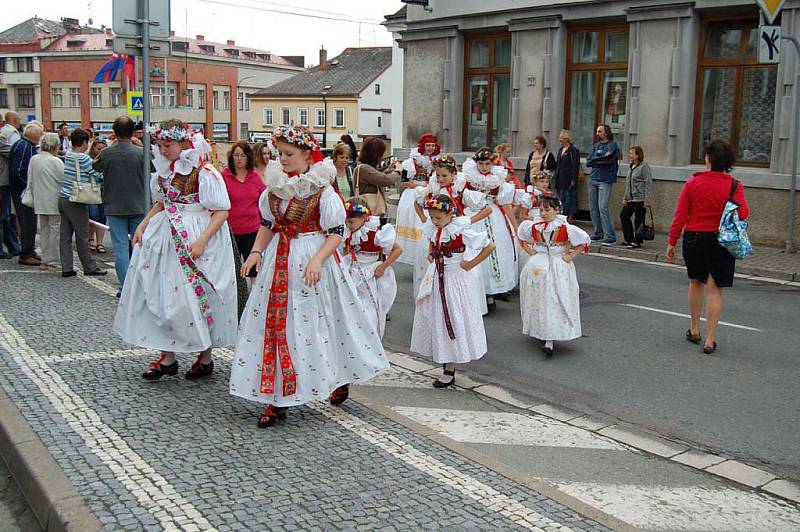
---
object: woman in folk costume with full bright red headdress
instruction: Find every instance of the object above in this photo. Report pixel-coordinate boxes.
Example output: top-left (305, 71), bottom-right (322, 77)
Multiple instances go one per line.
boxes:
top-left (397, 133), bottom-right (441, 295)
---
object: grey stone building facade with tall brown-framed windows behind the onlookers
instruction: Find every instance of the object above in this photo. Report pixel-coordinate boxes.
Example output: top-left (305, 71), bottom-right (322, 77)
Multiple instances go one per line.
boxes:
top-left (394, 0), bottom-right (800, 244)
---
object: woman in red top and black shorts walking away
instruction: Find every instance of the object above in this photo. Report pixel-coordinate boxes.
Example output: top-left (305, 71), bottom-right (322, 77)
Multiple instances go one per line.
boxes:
top-left (667, 139), bottom-right (750, 355)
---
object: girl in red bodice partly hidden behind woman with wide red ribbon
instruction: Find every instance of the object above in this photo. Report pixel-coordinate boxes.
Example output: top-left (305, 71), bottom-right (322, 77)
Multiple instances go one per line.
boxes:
top-left (342, 198), bottom-right (403, 338)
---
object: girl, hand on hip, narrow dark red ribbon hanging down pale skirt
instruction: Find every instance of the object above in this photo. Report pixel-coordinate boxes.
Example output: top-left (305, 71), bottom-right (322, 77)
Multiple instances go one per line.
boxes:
top-left (411, 194), bottom-right (494, 388)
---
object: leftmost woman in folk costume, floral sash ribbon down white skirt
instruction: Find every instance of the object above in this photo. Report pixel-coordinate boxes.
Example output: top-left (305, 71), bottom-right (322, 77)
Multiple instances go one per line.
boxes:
top-left (114, 119), bottom-right (237, 381)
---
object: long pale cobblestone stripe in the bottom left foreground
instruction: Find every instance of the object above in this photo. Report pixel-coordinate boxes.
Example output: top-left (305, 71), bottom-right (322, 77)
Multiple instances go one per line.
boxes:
top-left (0, 314), bottom-right (213, 529)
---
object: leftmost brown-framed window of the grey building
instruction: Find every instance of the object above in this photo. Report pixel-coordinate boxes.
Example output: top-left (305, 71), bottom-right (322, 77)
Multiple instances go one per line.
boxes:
top-left (463, 33), bottom-right (511, 149)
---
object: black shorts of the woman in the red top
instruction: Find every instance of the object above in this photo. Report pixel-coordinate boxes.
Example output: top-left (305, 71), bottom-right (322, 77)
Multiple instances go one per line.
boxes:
top-left (683, 231), bottom-right (736, 288)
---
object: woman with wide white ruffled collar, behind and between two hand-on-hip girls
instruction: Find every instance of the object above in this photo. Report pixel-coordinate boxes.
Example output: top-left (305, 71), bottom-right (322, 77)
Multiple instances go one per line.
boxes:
top-left (463, 148), bottom-right (524, 311)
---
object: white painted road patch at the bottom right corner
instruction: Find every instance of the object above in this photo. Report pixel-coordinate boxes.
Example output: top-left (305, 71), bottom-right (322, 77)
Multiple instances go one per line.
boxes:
top-left (552, 479), bottom-right (800, 532)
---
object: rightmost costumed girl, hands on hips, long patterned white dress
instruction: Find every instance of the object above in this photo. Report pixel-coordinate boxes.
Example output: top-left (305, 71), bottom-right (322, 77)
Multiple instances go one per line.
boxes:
top-left (518, 193), bottom-right (591, 356)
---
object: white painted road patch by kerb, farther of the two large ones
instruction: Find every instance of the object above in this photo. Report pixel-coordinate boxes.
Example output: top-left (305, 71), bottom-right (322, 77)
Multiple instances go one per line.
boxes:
top-left (392, 406), bottom-right (633, 451)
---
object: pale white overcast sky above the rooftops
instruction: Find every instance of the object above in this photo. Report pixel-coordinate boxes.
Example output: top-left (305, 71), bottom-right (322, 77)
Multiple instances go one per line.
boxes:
top-left (7, 0), bottom-right (403, 65)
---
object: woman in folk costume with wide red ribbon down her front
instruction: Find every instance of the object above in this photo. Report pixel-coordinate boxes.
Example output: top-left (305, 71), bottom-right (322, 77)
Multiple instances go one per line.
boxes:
top-left (230, 127), bottom-right (389, 428)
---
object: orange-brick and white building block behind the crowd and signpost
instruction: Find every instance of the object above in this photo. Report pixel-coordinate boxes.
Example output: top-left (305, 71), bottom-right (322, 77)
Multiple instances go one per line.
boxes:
top-left (0, 19), bottom-right (303, 140)
